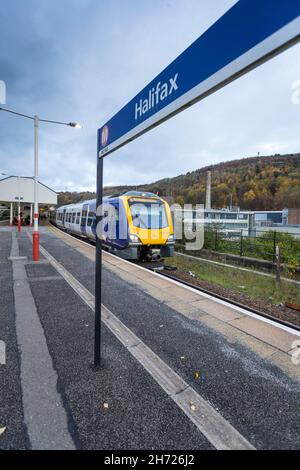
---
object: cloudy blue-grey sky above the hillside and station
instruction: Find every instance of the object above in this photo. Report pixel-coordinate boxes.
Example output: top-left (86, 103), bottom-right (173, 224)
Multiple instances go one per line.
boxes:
top-left (0, 0), bottom-right (300, 191)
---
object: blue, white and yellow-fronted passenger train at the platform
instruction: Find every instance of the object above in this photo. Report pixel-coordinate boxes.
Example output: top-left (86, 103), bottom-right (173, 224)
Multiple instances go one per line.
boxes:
top-left (51, 191), bottom-right (174, 261)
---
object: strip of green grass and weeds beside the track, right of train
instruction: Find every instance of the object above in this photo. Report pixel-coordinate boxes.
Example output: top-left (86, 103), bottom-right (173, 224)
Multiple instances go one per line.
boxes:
top-left (172, 255), bottom-right (300, 305)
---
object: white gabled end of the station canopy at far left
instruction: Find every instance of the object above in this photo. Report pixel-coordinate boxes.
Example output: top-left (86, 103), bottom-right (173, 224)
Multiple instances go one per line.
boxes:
top-left (0, 176), bottom-right (57, 206)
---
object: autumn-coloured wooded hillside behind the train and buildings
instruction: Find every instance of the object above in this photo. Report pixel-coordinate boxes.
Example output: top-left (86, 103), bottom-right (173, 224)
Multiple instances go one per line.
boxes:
top-left (59, 153), bottom-right (300, 210)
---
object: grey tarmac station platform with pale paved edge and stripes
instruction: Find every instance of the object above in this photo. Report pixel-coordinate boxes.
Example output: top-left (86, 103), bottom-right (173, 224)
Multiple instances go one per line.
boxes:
top-left (0, 227), bottom-right (300, 450)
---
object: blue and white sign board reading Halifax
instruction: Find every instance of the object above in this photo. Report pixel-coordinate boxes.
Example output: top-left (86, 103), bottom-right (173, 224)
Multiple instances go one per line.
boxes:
top-left (98, 0), bottom-right (300, 157)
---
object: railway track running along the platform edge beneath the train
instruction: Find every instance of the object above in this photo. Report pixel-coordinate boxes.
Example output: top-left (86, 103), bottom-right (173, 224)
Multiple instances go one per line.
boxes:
top-left (51, 225), bottom-right (300, 332)
